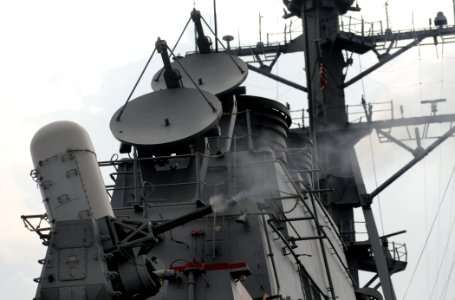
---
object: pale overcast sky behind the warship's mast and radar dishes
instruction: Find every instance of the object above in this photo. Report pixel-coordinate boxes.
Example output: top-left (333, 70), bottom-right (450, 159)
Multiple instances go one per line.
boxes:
top-left (0, 0), bottom-right (455, 299)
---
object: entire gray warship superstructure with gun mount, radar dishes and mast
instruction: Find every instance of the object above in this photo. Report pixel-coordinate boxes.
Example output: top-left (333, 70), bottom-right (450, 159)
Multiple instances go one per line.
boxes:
top-left (23, 0), bottom-right (455, 300)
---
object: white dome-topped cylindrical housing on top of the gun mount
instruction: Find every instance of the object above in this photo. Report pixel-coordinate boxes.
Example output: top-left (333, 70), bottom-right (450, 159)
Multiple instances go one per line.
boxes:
top-left (30, 121), bottom-right (114, 225)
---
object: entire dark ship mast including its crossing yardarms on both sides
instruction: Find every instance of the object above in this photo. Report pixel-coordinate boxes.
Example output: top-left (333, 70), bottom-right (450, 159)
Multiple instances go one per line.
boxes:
top-left (232, 0), bottom-right (455, 300)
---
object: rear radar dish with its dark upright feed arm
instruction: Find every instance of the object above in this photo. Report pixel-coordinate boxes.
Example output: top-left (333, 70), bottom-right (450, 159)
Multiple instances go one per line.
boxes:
top-left (152, 10), bottom-right (248, 96)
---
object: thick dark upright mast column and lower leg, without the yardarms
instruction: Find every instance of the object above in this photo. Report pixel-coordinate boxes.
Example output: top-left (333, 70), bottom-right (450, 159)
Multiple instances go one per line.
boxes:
top-left (301, 1), bottom-right (396, 300)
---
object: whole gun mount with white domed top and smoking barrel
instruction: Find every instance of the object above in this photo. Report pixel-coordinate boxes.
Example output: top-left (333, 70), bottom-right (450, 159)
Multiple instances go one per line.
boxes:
top-left (26, 121), bottom-right (216, 300)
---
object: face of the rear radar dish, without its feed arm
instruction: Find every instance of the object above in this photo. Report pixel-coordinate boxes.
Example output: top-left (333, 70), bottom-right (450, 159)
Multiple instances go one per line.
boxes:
top-left (152, 53), bottom-right (248, 95)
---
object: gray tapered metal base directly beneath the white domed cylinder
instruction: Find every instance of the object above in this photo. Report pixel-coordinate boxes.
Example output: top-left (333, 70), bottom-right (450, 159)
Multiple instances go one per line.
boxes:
top-left (35, 219), bottom-right (113, 300)
